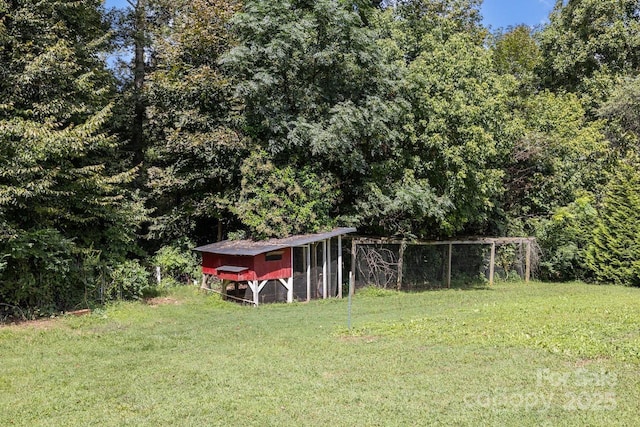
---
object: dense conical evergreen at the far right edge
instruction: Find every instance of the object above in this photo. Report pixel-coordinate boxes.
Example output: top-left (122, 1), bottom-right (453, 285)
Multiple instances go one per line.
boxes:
top-left (586, 159), bottom-right (640, 286)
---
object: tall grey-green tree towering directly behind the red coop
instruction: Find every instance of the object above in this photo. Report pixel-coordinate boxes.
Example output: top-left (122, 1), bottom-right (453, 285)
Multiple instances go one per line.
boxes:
top-left (223, 0), bottom-right (401, 239)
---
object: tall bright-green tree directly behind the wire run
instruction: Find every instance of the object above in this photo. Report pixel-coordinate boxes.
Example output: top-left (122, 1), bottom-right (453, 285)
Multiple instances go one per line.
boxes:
top-left (358, 0), bottom-right (514, 237)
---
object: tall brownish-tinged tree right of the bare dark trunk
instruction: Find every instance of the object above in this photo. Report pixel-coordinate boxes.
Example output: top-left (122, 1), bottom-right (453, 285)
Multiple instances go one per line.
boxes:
top-left (144, 0), bottom-right (246, 242)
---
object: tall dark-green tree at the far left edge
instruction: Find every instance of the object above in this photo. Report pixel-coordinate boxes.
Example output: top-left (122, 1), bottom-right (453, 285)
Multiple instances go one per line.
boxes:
top-left (0, 0), bottom-right (140, 314)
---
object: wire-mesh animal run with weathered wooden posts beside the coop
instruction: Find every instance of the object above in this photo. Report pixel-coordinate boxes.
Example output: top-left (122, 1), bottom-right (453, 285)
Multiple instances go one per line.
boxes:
top-left (351, 237), bottom-right (539, 290)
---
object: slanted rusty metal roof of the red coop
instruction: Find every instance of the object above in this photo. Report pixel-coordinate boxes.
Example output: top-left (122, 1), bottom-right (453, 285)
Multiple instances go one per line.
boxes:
top-left (194, 227), bottom-right (356, 256)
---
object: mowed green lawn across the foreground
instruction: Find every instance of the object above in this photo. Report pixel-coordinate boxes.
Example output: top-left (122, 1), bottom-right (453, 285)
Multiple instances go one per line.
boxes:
top-left (0, 283), bottom-right (640, 426)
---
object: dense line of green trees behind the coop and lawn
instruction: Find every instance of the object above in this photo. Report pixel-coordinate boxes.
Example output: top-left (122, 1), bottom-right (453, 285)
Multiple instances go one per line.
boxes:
top-left (0, 0), bottom-right (640, 311)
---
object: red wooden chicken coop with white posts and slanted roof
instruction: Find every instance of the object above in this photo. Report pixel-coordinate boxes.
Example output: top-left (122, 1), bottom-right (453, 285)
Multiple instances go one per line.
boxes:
top-left (194, 227), bottom-right (356, 305)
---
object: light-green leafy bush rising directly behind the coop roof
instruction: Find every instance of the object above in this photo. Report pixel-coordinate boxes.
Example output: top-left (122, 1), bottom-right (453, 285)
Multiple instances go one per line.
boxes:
top-left (233, 152), bottom-right (339, 239)
